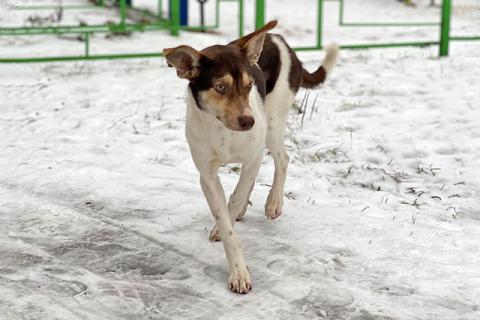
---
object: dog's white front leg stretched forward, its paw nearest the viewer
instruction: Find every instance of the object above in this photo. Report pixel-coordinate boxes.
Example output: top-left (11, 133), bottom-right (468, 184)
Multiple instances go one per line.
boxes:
top-left (200, 162), bottom-right (252, 293)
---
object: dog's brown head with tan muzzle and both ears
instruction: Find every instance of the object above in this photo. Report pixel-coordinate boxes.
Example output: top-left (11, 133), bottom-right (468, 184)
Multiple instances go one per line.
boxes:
top-left (163, 21), bottom-right (277, 131)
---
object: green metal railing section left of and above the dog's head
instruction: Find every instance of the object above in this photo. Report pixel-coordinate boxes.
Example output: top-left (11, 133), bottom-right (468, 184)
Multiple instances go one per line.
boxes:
top-left (0, 0), bottom-right (244, 63)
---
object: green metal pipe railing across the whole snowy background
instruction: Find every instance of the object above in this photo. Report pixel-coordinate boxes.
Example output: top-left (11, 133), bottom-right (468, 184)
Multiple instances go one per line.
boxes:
top-left (0, 0), bottom-right (480, 63)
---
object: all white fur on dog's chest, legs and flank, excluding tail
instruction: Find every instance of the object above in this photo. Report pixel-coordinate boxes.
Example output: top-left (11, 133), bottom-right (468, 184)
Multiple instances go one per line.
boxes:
top-left (186, 37), bottom-right (295, 292)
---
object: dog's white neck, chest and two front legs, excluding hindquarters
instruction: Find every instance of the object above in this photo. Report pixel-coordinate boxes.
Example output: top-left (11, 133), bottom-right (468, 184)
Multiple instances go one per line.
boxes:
top-left (186, 82), bottom-right (267, 292)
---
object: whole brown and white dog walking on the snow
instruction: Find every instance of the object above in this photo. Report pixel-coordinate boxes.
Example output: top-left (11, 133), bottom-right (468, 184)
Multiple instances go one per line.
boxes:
top-left (164, 21), bottom-right (338, 293)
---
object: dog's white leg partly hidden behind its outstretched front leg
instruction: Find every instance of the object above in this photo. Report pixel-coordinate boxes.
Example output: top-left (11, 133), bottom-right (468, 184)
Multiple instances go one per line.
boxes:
top-left (210, 156), bottom-right (262, 241)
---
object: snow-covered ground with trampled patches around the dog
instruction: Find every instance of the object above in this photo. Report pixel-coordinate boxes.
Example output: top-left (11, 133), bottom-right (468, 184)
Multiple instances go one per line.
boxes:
top-left (0, 0), bottom-right (480, 320)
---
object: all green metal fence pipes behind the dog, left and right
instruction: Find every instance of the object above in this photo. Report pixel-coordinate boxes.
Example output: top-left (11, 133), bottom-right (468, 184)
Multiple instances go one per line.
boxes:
top-left (0, 0), bottom-right (480, 63)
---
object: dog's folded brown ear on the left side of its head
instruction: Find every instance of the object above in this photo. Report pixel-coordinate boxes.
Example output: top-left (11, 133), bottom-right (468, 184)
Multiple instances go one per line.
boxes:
top-left (163, 46), bottom-right (201, 80)
